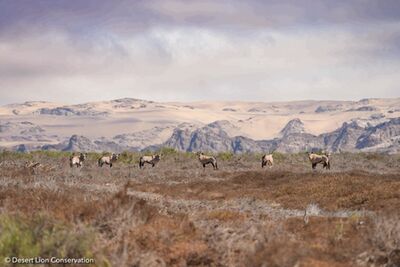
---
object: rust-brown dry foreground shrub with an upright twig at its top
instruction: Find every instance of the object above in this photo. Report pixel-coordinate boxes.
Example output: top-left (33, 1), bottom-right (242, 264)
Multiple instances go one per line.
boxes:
top-left (91, 184), bottom-right (216, 266)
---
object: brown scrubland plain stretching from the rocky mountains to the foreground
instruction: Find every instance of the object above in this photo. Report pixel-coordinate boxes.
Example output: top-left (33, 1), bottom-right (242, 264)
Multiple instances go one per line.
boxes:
top-left (0, 152), bottom-right (400, 267)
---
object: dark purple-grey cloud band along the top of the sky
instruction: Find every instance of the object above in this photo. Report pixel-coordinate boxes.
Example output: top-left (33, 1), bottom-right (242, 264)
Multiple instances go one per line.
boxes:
top-left (0, 0), bottom-right (400, 34)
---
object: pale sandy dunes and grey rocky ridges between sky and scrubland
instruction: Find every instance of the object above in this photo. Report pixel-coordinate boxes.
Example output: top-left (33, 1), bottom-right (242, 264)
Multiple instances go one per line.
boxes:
top-left (0, 98), bottom-right (400, 153)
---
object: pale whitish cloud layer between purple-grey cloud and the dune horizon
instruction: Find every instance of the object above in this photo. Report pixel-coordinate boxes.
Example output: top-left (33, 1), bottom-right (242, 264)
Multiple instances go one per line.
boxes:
top-left (0, 23), bottom-right (400, 103)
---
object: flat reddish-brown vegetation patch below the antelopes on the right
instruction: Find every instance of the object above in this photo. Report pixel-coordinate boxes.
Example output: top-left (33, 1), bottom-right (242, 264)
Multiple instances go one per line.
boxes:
top-left (134, 171), bottom-right (400, 212)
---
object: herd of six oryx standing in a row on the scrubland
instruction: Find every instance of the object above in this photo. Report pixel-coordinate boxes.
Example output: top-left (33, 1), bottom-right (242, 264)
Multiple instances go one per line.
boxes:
top-left (69, 152), bottom-right (331, 170)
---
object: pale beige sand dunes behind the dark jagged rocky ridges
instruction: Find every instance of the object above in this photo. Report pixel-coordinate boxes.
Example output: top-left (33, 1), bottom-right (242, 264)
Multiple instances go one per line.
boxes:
top-left (0, 98), bottom-right (400, 150)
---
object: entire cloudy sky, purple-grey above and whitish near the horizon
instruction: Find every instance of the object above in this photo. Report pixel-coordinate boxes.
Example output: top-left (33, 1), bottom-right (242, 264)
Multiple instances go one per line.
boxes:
top-left (0, 0), bottom-right (400, 104)
